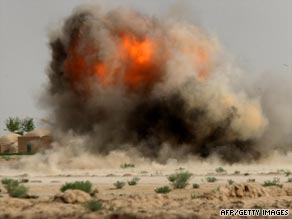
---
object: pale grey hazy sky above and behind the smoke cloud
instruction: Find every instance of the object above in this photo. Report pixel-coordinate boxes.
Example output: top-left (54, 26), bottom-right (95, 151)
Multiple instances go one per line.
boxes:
top-left (0, 0), bottom-right (292, 134)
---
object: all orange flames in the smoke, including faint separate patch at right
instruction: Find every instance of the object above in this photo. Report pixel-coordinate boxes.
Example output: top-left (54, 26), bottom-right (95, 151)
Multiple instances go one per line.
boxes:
top-left (64, 30), bottom-right (210, 92)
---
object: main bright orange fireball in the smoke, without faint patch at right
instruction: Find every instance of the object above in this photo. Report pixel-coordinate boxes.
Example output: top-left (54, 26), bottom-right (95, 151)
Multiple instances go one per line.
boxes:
top-left (64, 35), bottom-right (161, 90)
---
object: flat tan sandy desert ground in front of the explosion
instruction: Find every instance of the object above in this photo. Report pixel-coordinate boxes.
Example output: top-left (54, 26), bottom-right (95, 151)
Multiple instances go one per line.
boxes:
top-left (0, 157), bottom-right (292, 219)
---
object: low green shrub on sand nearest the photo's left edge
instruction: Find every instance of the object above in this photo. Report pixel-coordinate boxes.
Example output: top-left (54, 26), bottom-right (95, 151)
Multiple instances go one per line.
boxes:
top-left (1, 179), bottom-right (30, 198)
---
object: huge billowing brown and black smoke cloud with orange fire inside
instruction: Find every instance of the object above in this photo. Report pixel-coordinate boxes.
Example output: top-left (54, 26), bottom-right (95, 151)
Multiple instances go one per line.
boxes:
top-left (48, 5), bottom-right (267, 162)
